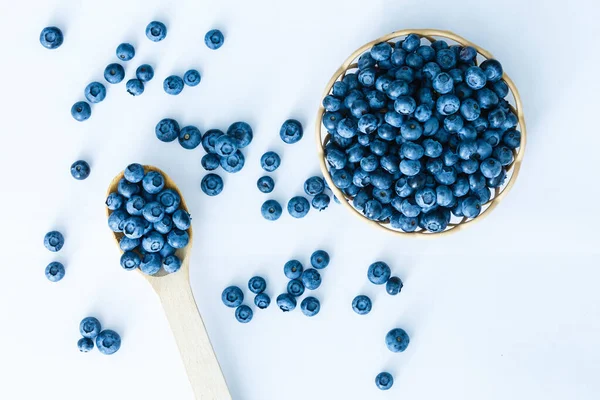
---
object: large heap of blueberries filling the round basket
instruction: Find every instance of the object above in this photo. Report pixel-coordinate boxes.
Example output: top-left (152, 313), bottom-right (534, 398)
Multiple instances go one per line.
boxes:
top-left (322, 34), bottom-right (521, 232)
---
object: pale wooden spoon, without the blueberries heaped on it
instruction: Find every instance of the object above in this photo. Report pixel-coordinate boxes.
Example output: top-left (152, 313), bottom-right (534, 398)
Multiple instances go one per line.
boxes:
top-left (106, 165), bottom-right (231, 400)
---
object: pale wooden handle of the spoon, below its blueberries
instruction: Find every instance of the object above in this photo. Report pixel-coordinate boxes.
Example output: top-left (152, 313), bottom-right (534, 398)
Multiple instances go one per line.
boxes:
top-left (155, 272), bottom-right (231, 400)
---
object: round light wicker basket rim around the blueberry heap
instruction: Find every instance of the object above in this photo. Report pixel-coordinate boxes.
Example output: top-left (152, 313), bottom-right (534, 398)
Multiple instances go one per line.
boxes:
top-left (315, 29), bottom-right (527, 238)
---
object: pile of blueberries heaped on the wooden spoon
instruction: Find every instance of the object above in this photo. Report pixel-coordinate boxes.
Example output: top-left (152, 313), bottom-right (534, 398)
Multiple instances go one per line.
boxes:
top-left (106, 164), bottom-right (191, 275)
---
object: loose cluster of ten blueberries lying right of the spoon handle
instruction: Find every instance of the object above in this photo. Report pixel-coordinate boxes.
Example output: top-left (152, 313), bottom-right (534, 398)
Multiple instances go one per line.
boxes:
top-left (221, 250), bottom-right (329, 323)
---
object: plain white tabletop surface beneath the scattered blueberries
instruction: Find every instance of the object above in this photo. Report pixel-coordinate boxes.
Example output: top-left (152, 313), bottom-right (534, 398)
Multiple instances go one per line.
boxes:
top-left (0, 0), bottom-right (600, 400)
